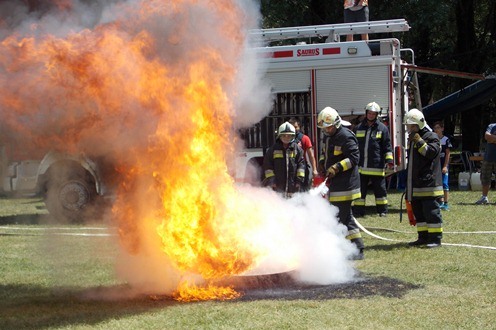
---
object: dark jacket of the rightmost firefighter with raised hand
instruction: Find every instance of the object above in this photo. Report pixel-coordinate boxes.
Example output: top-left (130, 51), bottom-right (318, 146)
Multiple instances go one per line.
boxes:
top-left (406, 127), bottom-right (444, 201)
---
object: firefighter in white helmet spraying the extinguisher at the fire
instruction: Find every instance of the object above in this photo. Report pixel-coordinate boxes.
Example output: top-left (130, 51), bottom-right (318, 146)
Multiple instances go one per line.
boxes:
top-left (317, 107), bottom-right (364, 260)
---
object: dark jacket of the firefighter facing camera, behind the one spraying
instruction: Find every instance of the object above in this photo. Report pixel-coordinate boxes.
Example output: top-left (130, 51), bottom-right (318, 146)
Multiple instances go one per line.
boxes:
top-left (356, 119), bottom-right (393, 176)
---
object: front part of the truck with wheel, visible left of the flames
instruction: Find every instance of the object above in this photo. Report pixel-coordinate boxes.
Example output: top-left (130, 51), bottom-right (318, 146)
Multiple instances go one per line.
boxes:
top-left (0, 141), bottom-right (104, 222)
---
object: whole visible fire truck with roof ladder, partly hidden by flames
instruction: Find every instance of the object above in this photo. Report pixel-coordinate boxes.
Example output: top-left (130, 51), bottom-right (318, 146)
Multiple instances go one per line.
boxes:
top-left (0, 19), bottom-right (419, 222)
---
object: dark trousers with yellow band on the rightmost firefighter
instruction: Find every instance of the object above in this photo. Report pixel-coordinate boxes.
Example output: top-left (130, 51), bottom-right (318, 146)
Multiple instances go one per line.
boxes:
top-left (411, 198), bottom-right (443, 244)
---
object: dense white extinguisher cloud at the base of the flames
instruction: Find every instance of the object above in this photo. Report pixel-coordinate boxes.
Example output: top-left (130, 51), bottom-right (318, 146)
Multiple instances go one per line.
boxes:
top-left (235, 186), bottom-right (357, 284)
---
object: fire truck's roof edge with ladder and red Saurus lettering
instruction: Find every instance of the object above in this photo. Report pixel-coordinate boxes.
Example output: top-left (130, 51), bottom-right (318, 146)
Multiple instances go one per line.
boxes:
top-left (249, 19), bottom-right (413, 70)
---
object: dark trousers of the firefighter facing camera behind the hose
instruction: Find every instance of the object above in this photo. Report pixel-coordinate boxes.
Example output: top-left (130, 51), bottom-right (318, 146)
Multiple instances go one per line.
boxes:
top-left (353, 174), bottom-right (388, 217)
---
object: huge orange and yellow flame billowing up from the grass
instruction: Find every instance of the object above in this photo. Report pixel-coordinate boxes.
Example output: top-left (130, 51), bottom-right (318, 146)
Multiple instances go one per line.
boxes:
top-left (0, 0), bottom-right (286, 301)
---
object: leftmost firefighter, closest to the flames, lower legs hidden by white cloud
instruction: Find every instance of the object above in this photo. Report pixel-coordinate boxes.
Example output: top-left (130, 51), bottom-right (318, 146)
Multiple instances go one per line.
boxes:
top-left (263, 122), bottom-right (305, 197)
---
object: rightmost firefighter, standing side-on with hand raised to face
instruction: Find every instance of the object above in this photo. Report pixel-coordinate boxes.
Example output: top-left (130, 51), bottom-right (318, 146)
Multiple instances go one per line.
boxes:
top-left (405, 109), bottom-right (443, 248)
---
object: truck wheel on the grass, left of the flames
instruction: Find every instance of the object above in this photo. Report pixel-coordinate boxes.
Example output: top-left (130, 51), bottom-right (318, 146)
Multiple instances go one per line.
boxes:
top-left (45, 179), bottom-right (96, 223)
